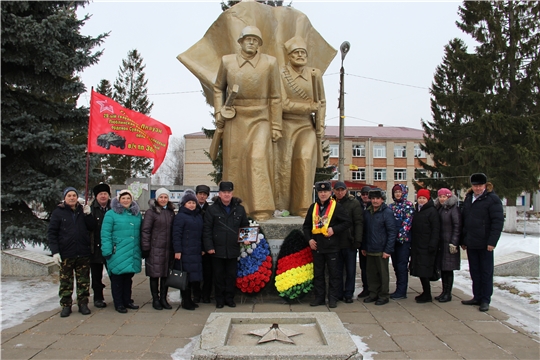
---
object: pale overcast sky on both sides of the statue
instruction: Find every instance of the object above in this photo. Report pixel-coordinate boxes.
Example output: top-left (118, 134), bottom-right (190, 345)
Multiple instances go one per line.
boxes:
top-left (78, 0), bottom-right (473, 137)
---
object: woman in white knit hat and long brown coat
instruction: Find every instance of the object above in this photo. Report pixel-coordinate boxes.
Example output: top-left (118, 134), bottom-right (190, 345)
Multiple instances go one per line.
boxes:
top-left (141, 188), bottom-right (174, 310)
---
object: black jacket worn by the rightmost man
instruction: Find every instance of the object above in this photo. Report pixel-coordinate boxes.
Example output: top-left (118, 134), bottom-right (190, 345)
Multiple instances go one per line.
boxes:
top-left (461, 182), bottom-right (504, 249)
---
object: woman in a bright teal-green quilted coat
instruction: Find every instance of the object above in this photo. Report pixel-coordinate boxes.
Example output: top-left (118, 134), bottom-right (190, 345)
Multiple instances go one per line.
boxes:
top-left (101, 190), bottom-right (141, 314)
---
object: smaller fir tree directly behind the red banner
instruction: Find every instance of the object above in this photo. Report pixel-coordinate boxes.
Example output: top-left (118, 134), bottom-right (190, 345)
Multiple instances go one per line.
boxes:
top-left (104, 49), bottom-right (154, 184)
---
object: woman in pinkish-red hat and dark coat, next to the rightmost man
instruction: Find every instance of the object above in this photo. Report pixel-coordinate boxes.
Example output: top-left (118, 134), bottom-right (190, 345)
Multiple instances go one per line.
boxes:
top-left (435, 188), bottom-right (461, 302)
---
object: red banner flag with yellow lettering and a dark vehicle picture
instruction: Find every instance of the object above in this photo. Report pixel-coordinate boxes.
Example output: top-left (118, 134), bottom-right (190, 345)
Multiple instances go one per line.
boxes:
top-left (88, 90), bottom-right (172, 174)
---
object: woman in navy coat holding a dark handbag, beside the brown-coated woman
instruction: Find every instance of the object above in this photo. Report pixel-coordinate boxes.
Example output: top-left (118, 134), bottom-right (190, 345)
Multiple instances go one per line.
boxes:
top-left (173, 189), bottom-right (203, 310)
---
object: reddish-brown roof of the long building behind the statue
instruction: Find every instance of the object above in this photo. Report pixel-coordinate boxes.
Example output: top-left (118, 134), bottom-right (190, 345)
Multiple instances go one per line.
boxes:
top-left (184, 126), bottom-right (424, 140)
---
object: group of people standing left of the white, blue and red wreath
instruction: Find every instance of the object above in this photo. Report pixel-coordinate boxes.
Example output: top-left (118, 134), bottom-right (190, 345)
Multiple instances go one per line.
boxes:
top-left (48, 181), bottom-right (249, 317)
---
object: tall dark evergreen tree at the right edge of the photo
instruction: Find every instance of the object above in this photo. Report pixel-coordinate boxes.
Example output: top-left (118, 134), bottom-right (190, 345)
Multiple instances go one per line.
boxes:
top-left (424, 1), bottom-right (540, 202)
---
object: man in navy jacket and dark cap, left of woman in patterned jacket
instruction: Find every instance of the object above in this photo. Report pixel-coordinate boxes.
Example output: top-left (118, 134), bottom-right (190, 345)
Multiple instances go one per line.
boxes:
top-left (362, 188), bottom-right (398, 305)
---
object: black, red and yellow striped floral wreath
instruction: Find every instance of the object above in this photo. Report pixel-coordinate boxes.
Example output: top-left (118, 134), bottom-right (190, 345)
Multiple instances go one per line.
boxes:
top-left (275, 230), bottom-right (313, 302)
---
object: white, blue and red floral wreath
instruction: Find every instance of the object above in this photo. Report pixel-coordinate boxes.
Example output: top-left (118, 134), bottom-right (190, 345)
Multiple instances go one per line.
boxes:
top-left (236, 221), bottom-right (272, 294)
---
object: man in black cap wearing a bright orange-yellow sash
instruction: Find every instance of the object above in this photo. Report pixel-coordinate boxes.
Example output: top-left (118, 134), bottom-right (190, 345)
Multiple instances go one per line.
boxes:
top-left (302, 181), bottom-right (351, 308)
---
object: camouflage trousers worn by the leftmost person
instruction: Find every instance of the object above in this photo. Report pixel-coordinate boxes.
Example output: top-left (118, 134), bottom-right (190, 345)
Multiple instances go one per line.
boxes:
top-left (58, 256), bottom-right (90, 307)
